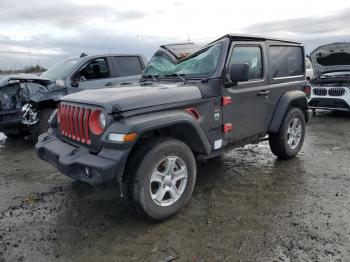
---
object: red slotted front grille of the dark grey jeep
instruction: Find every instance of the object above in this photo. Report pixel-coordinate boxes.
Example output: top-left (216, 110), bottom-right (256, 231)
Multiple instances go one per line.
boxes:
top-left (58, 103), bottom-right (91, 145)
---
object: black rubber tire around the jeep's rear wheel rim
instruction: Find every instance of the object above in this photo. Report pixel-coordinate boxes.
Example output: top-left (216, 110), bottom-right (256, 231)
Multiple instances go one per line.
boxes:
top-left (269, 107), bottom-right (305, 159)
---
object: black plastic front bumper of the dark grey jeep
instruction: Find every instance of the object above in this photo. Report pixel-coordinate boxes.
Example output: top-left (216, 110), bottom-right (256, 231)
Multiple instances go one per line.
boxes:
top-left (35, 133), bottom-right (129, 184)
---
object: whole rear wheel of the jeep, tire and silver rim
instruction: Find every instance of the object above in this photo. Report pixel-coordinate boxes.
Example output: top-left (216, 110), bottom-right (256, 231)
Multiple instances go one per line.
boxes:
top-left (269, 108), bottom-right (305, 159)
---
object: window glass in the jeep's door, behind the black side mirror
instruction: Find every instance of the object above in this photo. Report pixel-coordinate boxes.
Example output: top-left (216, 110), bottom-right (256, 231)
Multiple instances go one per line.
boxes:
top-left (230, 46), bottom-right (263, 80)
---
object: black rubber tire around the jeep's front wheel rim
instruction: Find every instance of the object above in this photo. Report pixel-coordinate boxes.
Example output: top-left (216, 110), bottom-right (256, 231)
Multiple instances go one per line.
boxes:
top-left (124, 137), bottom-right (196, 221)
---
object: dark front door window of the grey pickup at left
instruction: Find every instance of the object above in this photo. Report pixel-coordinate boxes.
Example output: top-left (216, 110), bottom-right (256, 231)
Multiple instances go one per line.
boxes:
top-left (80, 58), bottom-right (110, 81)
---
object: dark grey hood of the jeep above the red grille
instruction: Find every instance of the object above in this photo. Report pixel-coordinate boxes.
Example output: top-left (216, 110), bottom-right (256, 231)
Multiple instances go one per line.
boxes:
top-left (63, 83), bottom-right (202, 113)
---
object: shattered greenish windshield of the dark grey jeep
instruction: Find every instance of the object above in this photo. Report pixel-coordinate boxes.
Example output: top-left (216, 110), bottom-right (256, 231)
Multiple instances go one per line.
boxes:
top-left (144, 43), bottom-right (222, 77)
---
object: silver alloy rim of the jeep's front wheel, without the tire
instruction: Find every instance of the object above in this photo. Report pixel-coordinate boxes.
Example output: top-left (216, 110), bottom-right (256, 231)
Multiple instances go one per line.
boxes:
top-left (150, 156), bottom-right (188, 207)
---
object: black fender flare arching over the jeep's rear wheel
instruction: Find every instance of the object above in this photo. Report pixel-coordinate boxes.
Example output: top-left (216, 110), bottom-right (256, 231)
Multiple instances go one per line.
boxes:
top-left (268, 90), bottom-right (309, 133)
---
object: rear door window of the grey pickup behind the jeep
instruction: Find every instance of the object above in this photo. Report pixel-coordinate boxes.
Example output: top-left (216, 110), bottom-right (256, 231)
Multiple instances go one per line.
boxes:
top-left (114, 56), bottom-right (142, 76)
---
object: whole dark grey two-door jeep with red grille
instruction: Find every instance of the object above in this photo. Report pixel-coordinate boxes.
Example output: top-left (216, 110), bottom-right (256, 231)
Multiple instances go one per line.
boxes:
top-left (36, 35), bottom-right (308, 220)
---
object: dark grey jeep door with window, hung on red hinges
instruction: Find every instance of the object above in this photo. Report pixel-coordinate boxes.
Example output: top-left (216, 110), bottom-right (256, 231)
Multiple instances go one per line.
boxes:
top-left (223, 42), bottom-right (270, 143)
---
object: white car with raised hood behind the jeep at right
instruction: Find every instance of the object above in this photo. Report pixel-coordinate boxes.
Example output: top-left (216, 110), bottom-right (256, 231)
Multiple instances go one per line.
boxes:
top-left (309, 43), bottom-right (350, 113)
